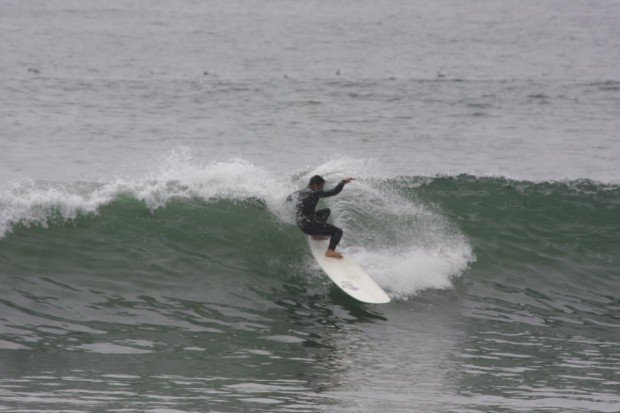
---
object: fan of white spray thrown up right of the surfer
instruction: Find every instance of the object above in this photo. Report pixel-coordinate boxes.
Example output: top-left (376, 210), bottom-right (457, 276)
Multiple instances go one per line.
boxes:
top-left (306, 171), bottom-right (475, 299)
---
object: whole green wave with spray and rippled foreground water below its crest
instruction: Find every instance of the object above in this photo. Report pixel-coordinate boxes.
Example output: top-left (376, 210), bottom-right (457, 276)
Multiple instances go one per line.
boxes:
top-left (0, 176), bottom-right (620, 411)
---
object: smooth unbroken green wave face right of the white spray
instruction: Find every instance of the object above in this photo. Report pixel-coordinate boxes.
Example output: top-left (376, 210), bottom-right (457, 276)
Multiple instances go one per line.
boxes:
top-left (406, 176), bottom-right (620, 280)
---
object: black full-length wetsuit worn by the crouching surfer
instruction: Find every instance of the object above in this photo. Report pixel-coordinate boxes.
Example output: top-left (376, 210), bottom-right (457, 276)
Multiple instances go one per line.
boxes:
top-left (297, 182), bottom-right (344, 250)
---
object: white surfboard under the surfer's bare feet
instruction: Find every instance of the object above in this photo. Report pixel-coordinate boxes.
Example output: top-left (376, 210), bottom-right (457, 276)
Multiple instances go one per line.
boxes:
top-left (308, 237), bottom-right (390, 304)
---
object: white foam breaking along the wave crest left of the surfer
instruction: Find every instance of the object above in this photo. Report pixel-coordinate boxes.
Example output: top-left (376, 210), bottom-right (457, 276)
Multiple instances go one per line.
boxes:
top-left (0, 149), bottom-right (302, 238)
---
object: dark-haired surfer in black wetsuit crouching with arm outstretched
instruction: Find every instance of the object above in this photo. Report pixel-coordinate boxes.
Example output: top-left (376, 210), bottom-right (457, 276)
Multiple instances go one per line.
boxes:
top-left (296, 175), bottom-right (353, 258)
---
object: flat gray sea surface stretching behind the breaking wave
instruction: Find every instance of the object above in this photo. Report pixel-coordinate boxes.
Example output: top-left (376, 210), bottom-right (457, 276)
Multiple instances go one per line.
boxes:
top-left (0, 0), bottom-right (620, 182)
